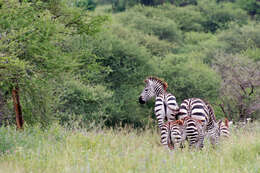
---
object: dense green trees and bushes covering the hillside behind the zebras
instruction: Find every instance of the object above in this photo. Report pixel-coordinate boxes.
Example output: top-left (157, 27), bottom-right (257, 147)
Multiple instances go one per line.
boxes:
top-left (0, 0), bottom-right (260, 127)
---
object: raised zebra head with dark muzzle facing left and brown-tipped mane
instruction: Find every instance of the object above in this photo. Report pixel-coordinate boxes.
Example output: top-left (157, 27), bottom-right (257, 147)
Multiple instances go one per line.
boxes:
top-left (139, 77), bottom-right (168, 104)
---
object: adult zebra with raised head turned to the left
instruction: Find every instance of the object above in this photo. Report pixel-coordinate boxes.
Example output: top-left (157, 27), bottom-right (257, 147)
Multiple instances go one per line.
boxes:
top-left (139, 77), bottom-right (179, 133)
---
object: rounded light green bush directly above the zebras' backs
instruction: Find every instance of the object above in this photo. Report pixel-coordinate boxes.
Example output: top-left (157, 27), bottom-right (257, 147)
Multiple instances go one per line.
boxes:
top-left (161, 55), bottom-right (220, 103)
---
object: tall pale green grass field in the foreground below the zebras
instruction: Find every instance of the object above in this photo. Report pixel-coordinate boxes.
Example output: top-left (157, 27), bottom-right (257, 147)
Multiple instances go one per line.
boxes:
top-left (0, 125), bottom-right (260, 173)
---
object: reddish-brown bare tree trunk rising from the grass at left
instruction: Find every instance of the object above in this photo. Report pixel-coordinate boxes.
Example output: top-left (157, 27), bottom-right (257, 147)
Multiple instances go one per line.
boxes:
top-left (12, 85), bottom-right (23, 129)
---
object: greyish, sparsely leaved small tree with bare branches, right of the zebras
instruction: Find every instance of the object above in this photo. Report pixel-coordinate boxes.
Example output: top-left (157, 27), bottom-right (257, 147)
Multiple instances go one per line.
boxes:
top-left (215, 54), bottom-right (260, 121)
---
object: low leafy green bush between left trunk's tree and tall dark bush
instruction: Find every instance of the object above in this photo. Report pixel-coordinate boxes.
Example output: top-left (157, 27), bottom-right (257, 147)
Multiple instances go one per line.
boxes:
top-left (57, 80), bottom-right (112, 126)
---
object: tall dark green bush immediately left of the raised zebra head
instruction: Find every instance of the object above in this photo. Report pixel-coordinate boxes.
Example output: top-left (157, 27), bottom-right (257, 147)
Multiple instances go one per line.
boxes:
top-left (79, 32), bottom-right (156, 126)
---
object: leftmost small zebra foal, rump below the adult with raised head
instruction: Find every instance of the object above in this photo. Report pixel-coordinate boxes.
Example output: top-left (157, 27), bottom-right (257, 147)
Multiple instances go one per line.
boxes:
top-left (161, 120), bottom-right (185, 150)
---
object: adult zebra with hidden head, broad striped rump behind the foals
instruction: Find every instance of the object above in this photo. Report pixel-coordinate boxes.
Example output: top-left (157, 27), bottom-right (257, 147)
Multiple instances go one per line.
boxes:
top-left (177, 98), bottom-right (220, 146)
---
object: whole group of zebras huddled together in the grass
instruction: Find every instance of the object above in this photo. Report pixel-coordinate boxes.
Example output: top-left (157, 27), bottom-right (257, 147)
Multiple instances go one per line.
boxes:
top-left (139, 77), bottom-right (229, 150)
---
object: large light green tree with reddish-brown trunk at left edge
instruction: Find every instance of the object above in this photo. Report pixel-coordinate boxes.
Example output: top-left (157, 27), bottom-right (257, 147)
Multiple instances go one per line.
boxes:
top-left (0, 0), bottom-right (106, 128)
